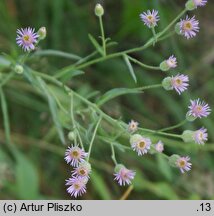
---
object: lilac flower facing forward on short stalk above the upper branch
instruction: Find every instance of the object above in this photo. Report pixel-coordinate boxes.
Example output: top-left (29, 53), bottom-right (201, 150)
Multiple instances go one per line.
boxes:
top-left (140, 10), bottom-right (160, 28)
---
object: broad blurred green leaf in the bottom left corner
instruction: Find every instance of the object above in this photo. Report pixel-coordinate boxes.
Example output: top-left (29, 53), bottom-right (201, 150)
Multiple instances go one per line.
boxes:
top-left (14, 152), bottom-right (39, 199)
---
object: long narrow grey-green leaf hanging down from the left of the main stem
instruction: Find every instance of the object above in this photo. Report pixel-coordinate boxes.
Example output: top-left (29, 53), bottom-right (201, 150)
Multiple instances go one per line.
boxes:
top-left (37, 78), bottom-right (65, 144)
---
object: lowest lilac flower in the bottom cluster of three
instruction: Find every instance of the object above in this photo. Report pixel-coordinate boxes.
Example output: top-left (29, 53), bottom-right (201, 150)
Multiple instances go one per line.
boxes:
top-left (65, 176), bottom-right (88, 198)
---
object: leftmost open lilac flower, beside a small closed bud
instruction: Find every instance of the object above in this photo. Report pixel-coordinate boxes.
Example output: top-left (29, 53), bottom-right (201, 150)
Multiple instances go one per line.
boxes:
top-left (16, 27), bottom-right (39, 51)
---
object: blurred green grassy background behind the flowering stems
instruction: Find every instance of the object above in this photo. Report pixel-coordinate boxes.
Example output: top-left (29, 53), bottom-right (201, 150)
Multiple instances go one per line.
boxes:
top-left (0, 0), bottom-right (214, 199)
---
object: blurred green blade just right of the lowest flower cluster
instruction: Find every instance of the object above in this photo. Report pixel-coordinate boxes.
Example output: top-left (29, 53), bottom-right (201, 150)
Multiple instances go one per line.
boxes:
top-left (91, 170), bottom-right (111, 200)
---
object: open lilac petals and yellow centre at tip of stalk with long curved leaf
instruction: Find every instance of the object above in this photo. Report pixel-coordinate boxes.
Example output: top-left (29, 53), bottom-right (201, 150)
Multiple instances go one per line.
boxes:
top-left (171, 74), bottom-right (189, 95)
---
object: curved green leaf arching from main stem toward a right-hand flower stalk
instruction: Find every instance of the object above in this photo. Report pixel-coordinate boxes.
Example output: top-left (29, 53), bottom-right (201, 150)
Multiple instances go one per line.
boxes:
top-left (97, 88), bottom-right (142, 106)
